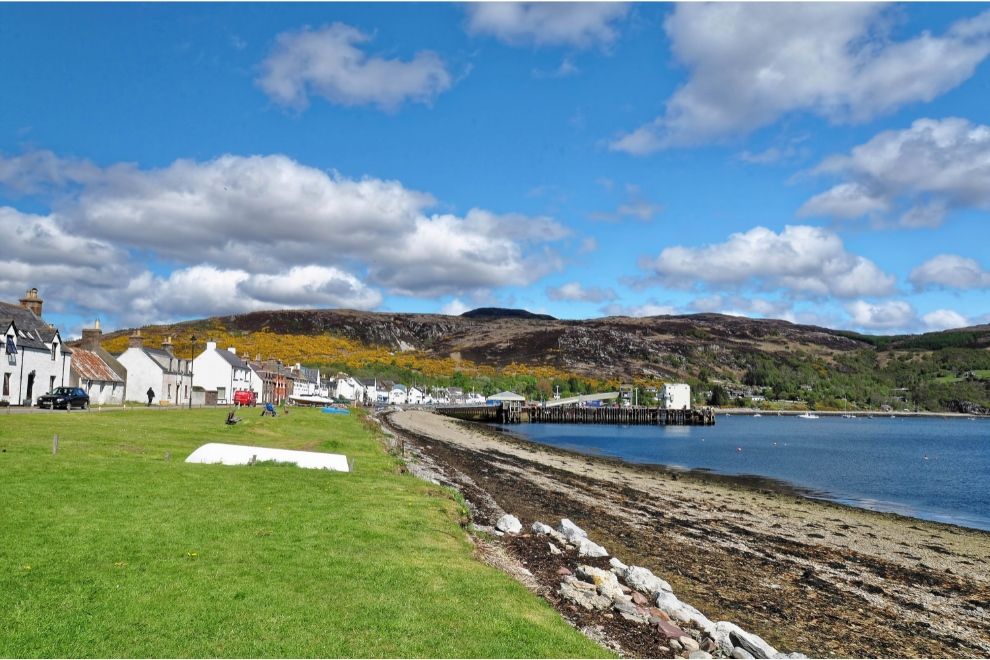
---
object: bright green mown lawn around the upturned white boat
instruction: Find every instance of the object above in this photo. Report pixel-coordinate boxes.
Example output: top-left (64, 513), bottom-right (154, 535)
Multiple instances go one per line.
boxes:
top-left (0, 409), bottom-right (605, 657)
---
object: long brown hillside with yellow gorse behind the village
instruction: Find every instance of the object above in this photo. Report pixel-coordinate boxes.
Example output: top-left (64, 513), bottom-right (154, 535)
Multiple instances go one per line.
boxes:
top-left (87, 308), bottom-right (990, 409)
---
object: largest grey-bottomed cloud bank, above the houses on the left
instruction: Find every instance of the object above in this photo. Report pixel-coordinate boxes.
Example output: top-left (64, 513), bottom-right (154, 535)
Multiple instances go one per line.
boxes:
top-left (0, 150), bottom-right (570, 320)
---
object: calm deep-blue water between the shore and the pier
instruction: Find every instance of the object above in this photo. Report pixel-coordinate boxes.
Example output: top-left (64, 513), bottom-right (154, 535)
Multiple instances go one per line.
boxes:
top-left (505, 415), bottom-right (990, 530)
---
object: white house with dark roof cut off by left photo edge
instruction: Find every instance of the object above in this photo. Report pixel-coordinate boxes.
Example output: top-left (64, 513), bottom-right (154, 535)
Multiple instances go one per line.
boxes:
top-left (0, 289), bottom-right (72, 406)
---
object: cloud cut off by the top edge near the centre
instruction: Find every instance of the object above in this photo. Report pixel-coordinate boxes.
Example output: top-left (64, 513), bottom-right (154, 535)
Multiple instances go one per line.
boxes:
top-left (466, 2), bottom-right (629, 48)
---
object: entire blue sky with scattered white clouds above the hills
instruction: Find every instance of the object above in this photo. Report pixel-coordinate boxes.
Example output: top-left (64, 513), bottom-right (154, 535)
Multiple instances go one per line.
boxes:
top-left (0, 3), bottom-right (990, 336)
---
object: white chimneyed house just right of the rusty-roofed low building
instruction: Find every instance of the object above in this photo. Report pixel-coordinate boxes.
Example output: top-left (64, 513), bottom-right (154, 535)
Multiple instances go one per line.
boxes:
top-left (117, 330), bottom-right (192, 405)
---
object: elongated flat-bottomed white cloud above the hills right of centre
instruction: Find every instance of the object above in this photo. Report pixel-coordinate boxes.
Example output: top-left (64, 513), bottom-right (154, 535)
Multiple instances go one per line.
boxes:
top-left (642, 225), bottom-right (894, 298)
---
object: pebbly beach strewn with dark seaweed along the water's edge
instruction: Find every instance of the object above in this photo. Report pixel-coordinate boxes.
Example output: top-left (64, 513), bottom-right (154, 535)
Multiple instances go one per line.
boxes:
top-left (385, 411), bottom-right (990, 657)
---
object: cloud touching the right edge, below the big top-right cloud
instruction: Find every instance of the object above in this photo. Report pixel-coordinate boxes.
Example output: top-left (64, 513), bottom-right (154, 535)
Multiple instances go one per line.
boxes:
top-left (798, 117), bottom-right (990, 227)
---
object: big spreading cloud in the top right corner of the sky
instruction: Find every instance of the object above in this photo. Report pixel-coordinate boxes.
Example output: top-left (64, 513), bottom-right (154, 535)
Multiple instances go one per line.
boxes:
top-left (611, 3), bottom-right (990, 154)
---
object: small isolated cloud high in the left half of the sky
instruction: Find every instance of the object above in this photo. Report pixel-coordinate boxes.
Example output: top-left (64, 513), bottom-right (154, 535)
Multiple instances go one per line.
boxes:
top-left (255, 23), bottom-right (451, 111)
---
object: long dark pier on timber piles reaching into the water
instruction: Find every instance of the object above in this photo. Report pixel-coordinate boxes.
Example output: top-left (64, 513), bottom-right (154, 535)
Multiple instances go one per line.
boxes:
top-left (437, 402), bottom-right (715, 426)
